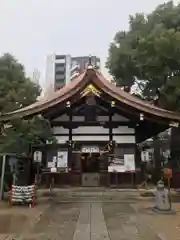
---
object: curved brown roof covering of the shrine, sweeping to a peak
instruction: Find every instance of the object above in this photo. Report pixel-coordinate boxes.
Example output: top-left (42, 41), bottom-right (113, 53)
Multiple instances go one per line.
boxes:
top-left (0, 69), bottom-right (180, 121)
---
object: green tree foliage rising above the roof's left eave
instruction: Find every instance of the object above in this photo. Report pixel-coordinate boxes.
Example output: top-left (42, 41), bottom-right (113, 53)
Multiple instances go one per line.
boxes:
top-left (0, 54), bottom-right (41, 114)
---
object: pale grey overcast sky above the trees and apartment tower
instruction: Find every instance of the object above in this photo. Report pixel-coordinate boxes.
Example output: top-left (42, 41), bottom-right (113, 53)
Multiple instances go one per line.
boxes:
top-left (0, 0), bottom-right (178, 85)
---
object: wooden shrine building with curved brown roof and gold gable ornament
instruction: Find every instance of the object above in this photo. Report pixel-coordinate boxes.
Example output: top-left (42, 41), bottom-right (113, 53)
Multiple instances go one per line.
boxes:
top-left (0, 60), bottom-right (180, 186)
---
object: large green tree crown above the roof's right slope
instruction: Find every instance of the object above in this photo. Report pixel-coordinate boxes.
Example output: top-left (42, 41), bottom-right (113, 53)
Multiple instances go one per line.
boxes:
top-left (107, 1), bottom-right (180, 110)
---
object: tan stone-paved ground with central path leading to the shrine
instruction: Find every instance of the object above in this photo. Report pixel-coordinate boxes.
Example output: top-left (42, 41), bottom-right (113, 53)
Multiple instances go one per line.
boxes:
top-left (0, 189), bottom-right (180, 240)
